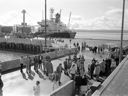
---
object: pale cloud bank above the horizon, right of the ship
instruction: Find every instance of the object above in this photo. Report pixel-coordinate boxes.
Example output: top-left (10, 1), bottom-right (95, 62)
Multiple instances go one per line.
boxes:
top-left (71, 9), bottom-right (128, 29)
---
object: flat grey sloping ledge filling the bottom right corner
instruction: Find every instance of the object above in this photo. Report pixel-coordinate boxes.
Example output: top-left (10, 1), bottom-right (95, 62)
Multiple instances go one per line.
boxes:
top-left (92, 56), bottom-right (128, 96)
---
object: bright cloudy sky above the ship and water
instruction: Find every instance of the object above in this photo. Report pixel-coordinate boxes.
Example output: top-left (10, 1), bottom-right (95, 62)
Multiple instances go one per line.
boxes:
top-left (0, 0), bottom-right (128, 29)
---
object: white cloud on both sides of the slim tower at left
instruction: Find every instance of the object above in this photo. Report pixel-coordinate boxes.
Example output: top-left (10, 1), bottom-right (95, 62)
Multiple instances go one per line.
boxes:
top-left (0, 10), bottom-right (37, 26)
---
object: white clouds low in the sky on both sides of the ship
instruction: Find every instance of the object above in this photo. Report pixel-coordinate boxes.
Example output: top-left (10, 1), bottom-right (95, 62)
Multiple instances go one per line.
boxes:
top-left (0, 8), bottom-right (128, 30)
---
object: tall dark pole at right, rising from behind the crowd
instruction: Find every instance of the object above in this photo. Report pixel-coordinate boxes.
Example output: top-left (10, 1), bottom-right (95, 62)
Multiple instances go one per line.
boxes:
top-left (119, 0), bottom-right (125, 63)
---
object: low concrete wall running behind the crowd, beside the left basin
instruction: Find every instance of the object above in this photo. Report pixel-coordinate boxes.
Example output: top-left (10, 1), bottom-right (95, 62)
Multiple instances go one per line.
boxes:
top-left (0, 48), bottom-right (77, 74)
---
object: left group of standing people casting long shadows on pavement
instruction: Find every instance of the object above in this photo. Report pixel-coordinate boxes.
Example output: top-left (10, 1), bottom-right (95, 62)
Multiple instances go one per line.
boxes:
top-left (20, 55), bottom-right (53, 79)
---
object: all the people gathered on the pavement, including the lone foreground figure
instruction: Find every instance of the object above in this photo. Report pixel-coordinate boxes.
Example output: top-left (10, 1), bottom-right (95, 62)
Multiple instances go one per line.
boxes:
top-left (0, 39), bottom-right (124, 96)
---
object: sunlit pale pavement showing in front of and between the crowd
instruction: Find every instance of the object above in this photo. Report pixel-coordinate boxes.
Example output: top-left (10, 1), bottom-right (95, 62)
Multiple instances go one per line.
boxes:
top-left (2, 51), bottom-right (105, 96)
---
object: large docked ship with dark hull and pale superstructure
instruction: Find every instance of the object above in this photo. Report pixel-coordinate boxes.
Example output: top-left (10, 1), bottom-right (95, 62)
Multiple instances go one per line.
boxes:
top-left (34, 8), bottom-right (76, 38)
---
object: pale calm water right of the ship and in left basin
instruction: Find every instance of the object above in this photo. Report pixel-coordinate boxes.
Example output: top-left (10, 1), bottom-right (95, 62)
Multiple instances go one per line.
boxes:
top-left (0, 31), bottom-right (128, 62)
